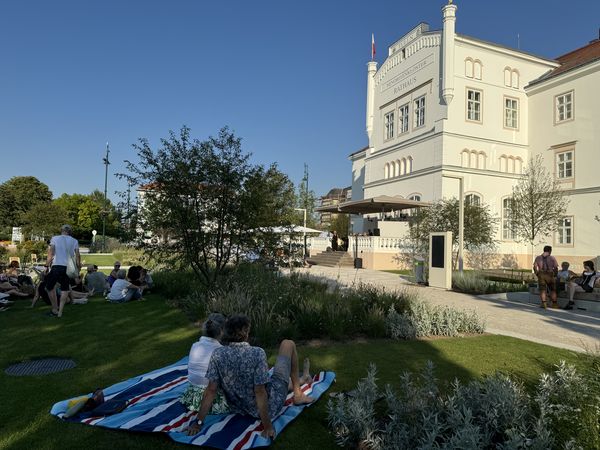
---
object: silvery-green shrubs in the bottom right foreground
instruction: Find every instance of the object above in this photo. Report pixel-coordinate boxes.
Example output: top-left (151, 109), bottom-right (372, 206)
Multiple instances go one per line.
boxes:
top-left (328, 362), bottom-right (600, 450)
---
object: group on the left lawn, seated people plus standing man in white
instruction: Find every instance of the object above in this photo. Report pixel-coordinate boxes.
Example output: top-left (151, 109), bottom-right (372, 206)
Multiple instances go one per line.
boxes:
top-left (0, 225), bottom-right (153, 317)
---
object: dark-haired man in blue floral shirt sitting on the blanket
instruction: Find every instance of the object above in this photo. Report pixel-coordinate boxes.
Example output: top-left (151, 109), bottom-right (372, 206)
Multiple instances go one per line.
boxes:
top-left (187, 315), bottom-right (314, 438)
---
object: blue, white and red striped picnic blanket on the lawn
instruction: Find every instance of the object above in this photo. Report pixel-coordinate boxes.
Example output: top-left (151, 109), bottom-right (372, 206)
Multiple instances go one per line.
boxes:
top-left (50, 356), bottom-right (335, 450)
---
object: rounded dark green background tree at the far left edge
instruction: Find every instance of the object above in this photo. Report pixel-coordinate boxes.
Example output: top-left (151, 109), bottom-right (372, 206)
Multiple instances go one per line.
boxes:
top-left (0, 177), bottom-right (52, 226)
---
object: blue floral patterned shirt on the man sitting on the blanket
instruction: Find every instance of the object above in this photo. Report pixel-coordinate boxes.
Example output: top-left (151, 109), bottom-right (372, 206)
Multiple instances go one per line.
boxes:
top-left (206, 342), bottom-right (282, 418)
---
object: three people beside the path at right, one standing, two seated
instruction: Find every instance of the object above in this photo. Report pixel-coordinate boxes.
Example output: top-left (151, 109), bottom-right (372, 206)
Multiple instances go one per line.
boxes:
top-left (533, 245), bottom-right (600, 310)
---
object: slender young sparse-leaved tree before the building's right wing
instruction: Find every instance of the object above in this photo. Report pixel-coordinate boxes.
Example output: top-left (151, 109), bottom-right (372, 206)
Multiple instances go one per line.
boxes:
top-left (509, 155), bottom-right (569, 254)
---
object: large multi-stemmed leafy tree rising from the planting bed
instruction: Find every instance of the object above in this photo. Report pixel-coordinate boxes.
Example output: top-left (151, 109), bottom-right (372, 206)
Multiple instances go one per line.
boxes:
top-left (118, 126), bottom-right (293, 285)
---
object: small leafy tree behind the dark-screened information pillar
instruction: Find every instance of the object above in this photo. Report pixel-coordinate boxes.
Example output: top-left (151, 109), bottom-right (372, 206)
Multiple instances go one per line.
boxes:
top-left (409, 198), bottom-right (498, 266)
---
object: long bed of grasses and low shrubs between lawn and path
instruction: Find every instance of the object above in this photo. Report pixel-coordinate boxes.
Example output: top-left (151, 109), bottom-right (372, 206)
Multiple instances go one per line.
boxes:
top-left (166, 264), bottom-right (483, 346)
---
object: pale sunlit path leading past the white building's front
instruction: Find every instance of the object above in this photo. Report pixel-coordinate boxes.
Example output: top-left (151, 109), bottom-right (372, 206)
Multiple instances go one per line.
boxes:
top-left (286, 266), bottom-right (600, 352)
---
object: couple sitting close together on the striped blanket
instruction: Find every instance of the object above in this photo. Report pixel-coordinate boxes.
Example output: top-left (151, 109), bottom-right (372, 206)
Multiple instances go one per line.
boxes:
top-left (180, 313), bottom-right (313, 438)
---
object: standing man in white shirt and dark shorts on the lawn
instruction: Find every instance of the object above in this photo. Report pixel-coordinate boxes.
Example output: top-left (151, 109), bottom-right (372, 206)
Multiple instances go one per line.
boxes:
top-left (46, 225), bottom-right (81, 317)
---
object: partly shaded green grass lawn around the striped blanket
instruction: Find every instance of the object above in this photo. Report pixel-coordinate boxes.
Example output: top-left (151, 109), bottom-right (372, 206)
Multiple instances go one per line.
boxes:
top-left (0, 295), bottom-right (587, 450)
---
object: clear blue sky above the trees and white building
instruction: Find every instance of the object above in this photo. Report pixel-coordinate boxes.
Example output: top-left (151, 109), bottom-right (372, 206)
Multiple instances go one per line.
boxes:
top-left (0, 0), bottom-right (600, 204)
